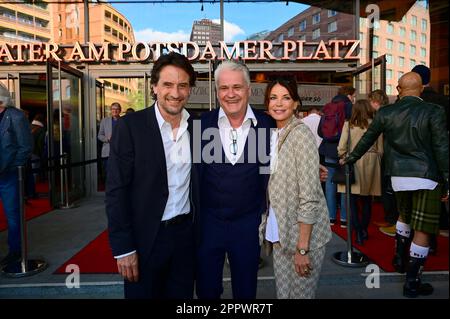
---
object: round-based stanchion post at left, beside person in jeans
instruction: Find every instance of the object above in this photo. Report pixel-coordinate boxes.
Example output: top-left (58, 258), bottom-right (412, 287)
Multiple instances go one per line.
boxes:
top-left (2, 166), bottom-right (48, 278)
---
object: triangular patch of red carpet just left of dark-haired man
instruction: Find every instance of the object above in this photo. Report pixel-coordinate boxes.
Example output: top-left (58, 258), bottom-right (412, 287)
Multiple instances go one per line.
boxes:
top-left (55, 230), bottom-right (117, 274)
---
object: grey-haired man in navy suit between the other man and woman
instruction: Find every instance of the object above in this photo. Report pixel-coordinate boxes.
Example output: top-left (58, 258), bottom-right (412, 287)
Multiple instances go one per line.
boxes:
top-left (196, 61), bottom-right (274, 299)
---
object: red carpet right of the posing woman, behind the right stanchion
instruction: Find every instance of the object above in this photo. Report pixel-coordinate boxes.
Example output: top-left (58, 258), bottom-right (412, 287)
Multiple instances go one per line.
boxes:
top-left (331, 203), bottom-right (449, 272)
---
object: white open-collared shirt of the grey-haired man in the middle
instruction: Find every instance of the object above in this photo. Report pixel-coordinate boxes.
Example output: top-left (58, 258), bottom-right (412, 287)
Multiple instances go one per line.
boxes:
top-left (217, 105), bottom-right (258, 165)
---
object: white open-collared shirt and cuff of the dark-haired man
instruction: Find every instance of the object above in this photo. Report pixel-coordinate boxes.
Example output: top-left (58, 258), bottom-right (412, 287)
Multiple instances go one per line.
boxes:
top-left (114, 103), bottom-right (191, 259)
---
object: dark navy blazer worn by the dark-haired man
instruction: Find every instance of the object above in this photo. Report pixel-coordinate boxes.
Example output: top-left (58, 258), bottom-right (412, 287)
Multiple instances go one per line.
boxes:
top-left (106, 105), bottom-right (199, 262)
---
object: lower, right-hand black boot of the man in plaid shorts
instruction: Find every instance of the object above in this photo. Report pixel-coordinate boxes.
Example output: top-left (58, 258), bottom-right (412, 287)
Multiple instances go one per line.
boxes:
top-left (403, 257), bottom-right (434, 298)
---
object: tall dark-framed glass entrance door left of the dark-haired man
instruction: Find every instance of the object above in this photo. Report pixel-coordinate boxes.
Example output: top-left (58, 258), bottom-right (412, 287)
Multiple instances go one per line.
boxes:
top-left (47, 62), bottom-right (86, 207)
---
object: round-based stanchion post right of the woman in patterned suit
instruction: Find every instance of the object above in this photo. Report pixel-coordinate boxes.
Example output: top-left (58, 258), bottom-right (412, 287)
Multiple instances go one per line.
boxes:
top-left (332, 164), bottom-right (369, 267)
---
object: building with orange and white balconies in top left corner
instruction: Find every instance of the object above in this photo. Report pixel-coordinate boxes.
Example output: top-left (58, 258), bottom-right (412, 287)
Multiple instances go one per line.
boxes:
top-left (0, 1), bottom-right (51, 43)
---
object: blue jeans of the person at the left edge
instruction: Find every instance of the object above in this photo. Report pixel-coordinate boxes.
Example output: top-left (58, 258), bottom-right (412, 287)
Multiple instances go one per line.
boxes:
top-left (0, 170), bottom-right (20, 252)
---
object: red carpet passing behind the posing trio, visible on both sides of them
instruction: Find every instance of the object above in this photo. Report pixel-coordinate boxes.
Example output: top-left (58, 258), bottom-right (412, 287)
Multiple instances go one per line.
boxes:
top-left (55, 203), bottom-right (448, 274)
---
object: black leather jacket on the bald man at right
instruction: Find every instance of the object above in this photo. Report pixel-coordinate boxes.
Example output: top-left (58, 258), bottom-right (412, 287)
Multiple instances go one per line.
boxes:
top-left (348, 96), bottom-right (448, 182)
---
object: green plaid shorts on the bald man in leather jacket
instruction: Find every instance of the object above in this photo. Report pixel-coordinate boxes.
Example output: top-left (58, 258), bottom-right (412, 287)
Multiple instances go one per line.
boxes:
top-left (395, 185), bottom-right (442, 234)
